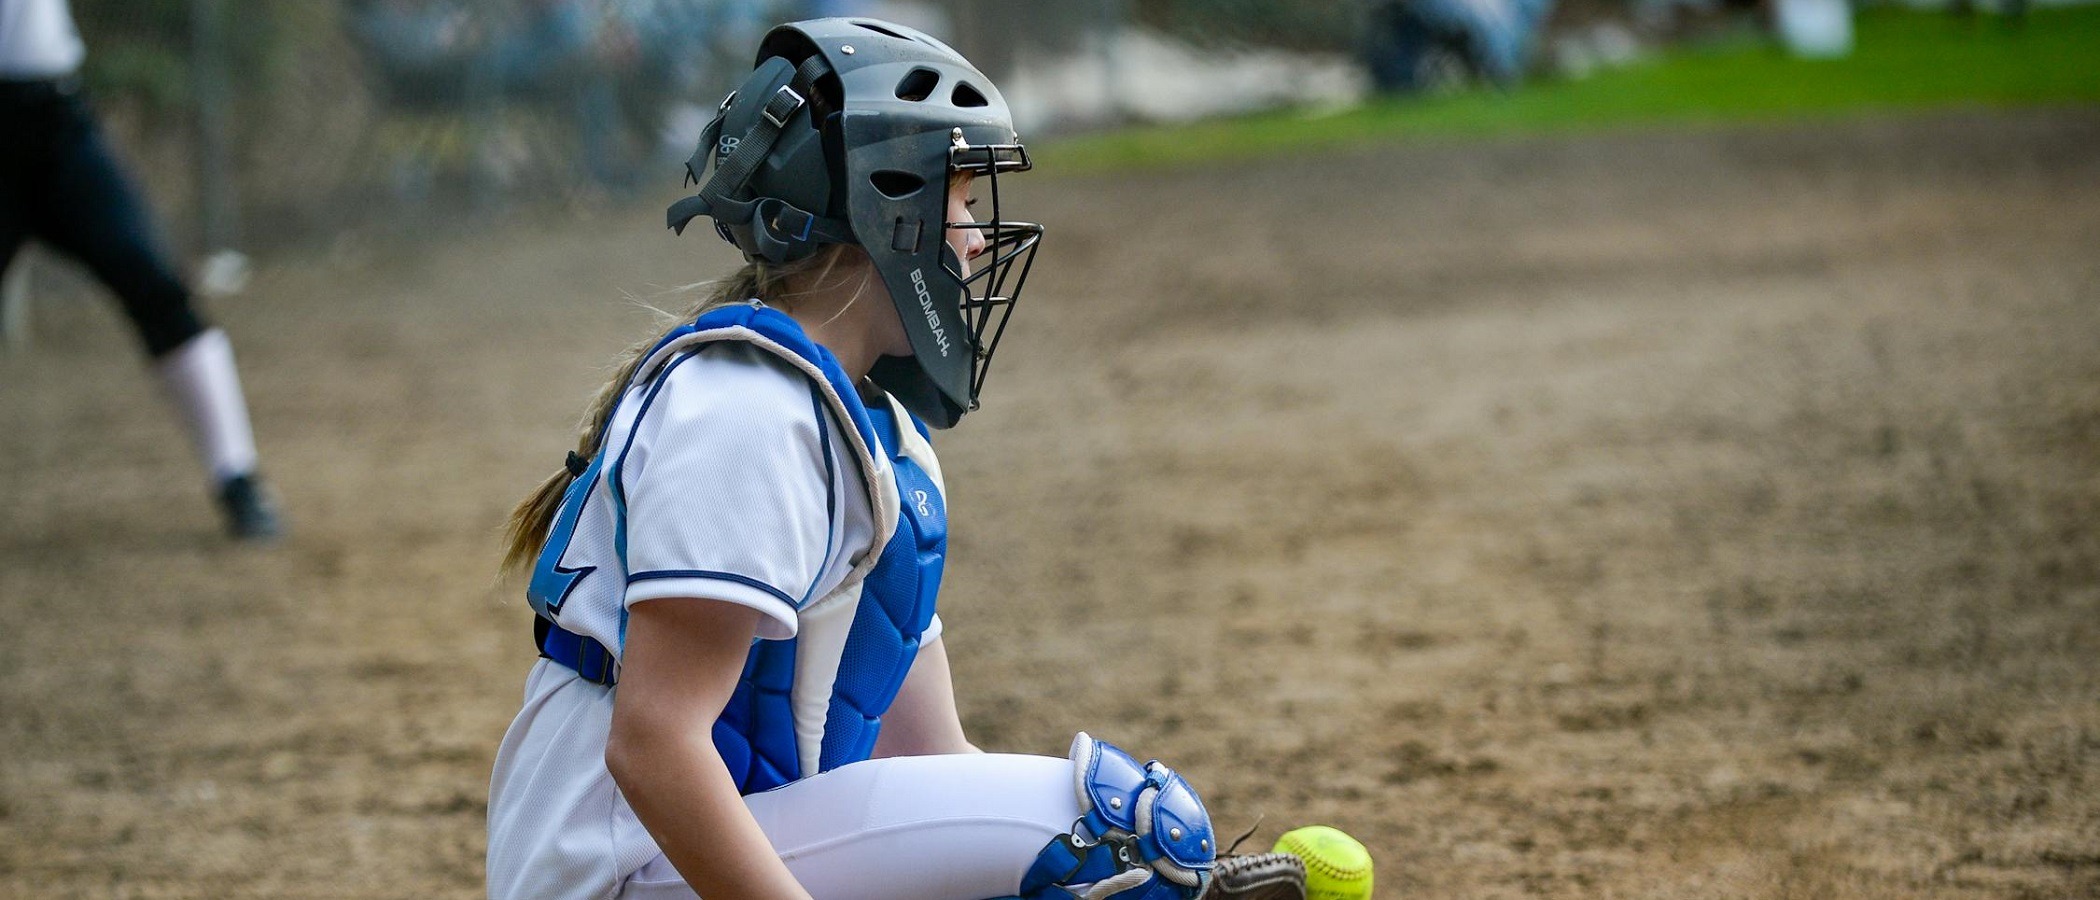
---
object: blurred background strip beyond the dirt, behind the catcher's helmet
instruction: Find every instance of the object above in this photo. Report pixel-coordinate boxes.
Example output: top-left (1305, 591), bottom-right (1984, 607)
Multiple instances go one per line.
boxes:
top-left (45, 0), bottom-right (2049, 266)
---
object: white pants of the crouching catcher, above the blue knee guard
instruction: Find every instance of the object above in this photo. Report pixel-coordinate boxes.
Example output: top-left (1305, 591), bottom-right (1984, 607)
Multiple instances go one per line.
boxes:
top-left (489, 661), bottom-right (1079, 900)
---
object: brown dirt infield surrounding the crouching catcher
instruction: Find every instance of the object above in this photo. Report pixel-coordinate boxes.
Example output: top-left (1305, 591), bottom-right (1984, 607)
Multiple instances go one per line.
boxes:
top-left (0, 111), bottom-right (2100, 898)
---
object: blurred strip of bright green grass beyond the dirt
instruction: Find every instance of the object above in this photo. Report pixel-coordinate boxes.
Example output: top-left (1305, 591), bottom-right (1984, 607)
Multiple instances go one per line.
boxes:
top-left (1037, 6), bottom-right (2100, 172)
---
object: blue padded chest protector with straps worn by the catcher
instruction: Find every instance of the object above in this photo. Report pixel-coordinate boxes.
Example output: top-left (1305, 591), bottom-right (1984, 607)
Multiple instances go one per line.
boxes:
top-left (529, 304), bottom-right (947, 793)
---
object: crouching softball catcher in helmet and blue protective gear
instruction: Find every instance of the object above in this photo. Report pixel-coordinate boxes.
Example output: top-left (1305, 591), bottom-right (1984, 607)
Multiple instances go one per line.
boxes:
top-left (487, 19), bottom-right (1302, 900)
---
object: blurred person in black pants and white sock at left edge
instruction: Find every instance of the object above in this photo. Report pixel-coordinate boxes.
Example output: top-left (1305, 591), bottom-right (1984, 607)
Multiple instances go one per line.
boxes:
top-left (0, 0), bottom-right (284, 539)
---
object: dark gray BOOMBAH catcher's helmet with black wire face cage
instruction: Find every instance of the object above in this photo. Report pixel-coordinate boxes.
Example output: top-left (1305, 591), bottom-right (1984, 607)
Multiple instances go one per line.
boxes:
top-left (668, 19), bottom-right (1042, 428)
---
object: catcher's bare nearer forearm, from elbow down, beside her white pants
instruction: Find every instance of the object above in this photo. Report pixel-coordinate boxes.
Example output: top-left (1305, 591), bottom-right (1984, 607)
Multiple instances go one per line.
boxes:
top-left (605, 728), bottom-right (809, 900)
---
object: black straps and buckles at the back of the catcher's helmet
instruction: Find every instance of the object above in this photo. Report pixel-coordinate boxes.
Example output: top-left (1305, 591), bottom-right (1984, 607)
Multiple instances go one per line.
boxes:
top-left (664, 55), bottom-right (859, 264)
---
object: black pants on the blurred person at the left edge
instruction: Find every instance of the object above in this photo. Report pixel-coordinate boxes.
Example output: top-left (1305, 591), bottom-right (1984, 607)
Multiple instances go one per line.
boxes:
top-left (0, 80), bottom-right (206, 357)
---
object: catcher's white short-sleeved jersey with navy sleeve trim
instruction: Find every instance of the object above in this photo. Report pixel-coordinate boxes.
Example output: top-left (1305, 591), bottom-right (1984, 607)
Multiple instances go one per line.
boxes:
top-left (557, 342), bottom-right (876, 637)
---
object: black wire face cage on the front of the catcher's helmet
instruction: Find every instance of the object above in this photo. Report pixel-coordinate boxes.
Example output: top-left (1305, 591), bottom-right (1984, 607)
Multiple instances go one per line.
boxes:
top-left (941, 128), bottom-right (1044, 409)
